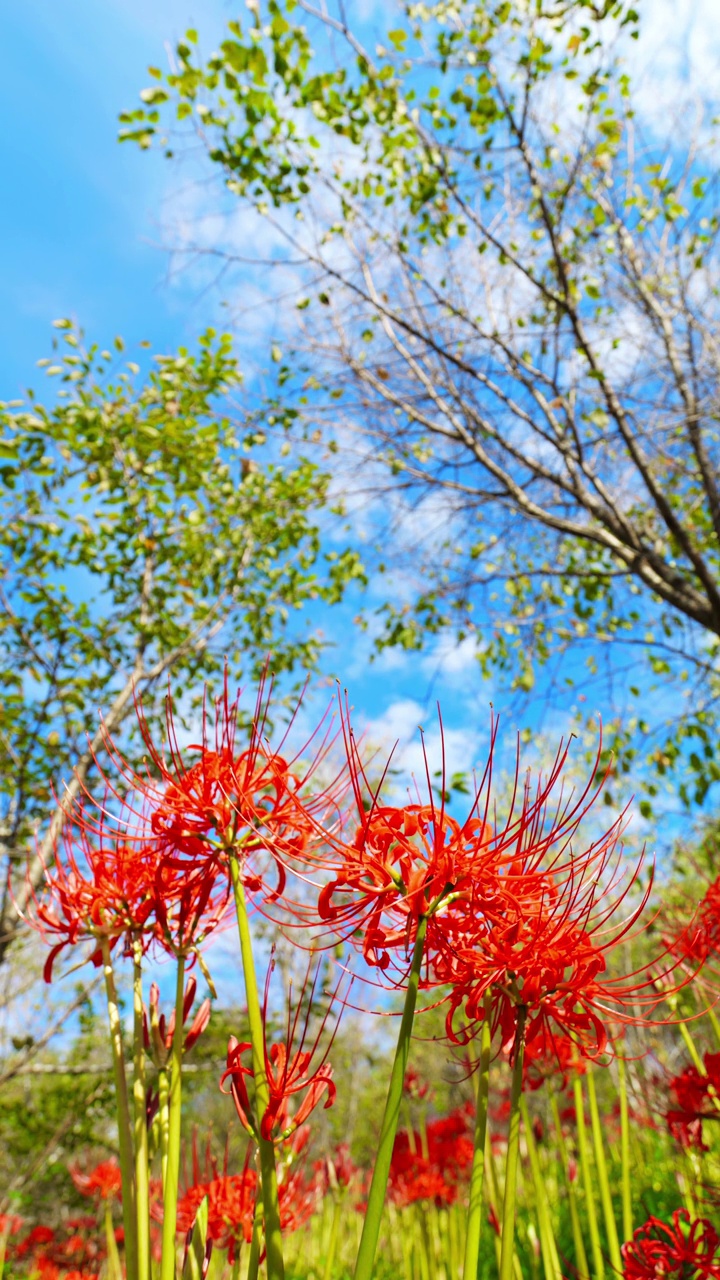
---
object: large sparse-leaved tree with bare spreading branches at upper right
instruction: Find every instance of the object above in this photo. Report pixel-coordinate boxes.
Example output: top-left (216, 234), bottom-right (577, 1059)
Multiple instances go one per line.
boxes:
top-left (122, 0), bottom-right (720, 812)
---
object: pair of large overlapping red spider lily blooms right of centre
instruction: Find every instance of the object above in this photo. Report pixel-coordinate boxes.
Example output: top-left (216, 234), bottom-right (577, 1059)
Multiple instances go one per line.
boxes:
top-left (304, 701), bottom-right (678, 1057)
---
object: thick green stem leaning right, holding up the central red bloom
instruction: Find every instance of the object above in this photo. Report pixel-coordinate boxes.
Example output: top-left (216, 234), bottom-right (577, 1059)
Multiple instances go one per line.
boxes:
top-left (355, 915), bottom-right (428, 1280)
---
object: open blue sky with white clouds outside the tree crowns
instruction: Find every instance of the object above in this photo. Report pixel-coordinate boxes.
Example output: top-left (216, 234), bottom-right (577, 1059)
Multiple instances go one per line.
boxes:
top-left (0, 0), bottom-right (720, 849)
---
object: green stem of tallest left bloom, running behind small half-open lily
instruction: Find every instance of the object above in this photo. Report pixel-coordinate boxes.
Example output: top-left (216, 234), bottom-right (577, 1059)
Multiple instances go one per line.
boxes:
top-left (229, 854), bottom-right (284, 1280)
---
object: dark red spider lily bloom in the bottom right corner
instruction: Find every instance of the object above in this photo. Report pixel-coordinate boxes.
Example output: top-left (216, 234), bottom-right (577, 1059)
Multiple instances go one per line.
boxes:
top-left (621, 1208), bottom-right (720, 1280)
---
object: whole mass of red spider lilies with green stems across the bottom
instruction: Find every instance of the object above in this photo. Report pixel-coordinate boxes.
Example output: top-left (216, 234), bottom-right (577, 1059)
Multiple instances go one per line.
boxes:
top-left (15, 687), bottom-right (720, 1280)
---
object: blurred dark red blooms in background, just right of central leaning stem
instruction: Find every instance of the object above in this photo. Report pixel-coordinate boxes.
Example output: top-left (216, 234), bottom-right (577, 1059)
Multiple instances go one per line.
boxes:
top-left (388, 1107), bottom-right (473, 1207)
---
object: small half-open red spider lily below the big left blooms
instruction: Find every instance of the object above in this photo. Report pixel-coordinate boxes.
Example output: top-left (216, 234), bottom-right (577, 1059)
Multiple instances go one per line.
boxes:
top-left (220, 959), bottom-right (340, 1142)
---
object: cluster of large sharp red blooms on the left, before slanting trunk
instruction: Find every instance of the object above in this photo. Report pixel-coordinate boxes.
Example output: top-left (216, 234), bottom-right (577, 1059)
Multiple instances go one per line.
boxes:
top-left (23, 686), bottom-right (329, 980)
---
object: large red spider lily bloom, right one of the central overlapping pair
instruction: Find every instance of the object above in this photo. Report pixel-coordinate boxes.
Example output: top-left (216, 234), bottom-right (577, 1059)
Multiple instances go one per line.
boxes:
top-left (434, 747), bottom-right (689, 1057)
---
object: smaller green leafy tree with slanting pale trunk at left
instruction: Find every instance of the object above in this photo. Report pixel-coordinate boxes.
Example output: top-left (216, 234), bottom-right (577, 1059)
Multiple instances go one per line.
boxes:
top-left (0, 321), bottom-right (361, 960)
